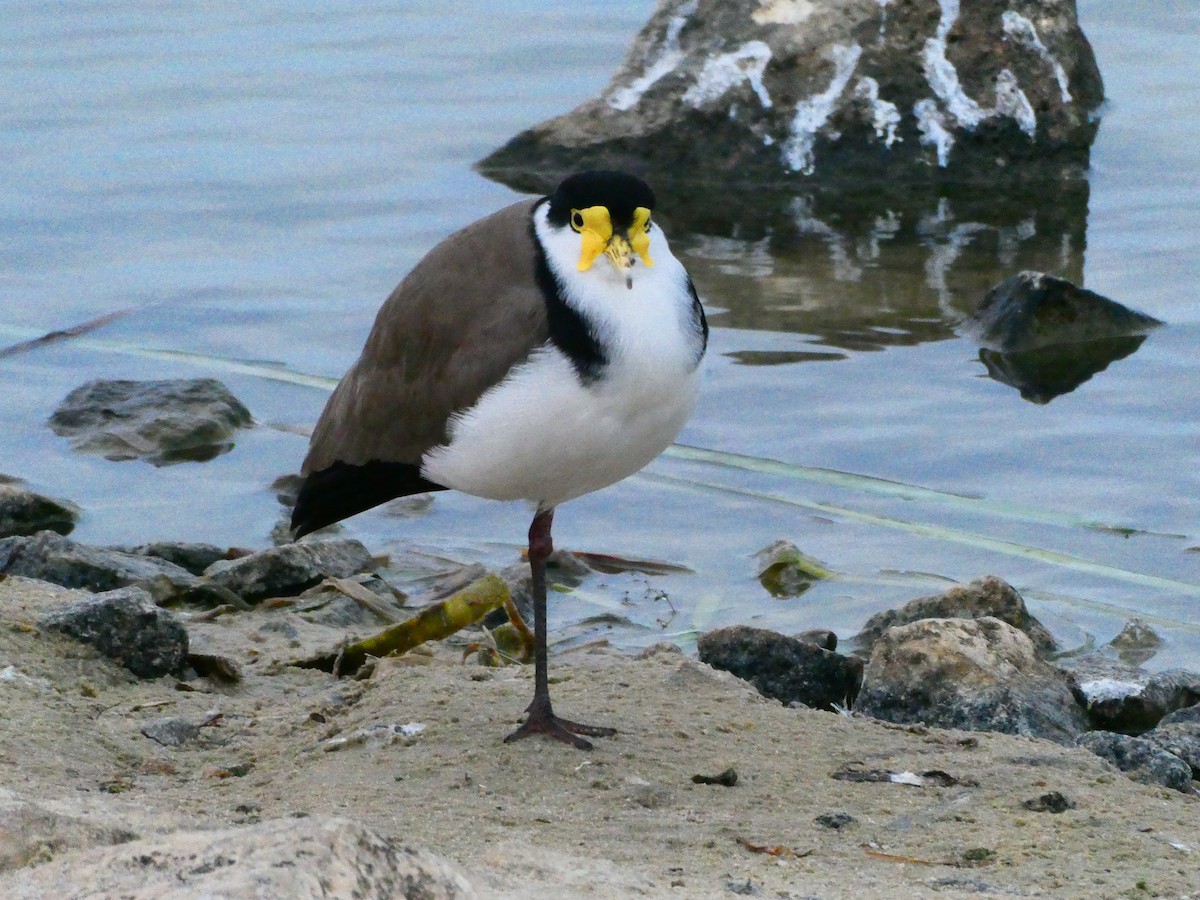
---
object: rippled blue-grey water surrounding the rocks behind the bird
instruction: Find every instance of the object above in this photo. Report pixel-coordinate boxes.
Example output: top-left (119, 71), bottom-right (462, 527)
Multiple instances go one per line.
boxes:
top-left (0, 0), bottom-right (1200, 666)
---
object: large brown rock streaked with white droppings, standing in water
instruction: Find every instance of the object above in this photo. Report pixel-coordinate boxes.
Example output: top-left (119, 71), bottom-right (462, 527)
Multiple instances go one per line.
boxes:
top-left (480, 0), bottom-right (1104, 186)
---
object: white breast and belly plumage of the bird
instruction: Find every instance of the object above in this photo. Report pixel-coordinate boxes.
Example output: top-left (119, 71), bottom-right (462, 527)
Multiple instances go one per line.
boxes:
top-left (421, 207), bottom-right (698, 508)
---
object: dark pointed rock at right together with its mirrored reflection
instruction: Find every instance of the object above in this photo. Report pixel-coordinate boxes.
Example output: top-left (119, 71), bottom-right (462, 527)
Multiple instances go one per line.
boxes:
top-left (964, 271), bottom-right (1163, 403)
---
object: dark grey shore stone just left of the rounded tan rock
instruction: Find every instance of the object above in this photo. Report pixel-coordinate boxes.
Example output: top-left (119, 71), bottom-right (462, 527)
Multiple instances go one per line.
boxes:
top-left (696, 625), bottom-right (863, 709)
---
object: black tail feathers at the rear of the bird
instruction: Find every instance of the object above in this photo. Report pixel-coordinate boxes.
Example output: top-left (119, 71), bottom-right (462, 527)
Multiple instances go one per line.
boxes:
top-left (292, 461), bottom-right (446, 538)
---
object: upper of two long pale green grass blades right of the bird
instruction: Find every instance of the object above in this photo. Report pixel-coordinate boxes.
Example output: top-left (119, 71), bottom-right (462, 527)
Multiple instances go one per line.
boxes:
top-left (662, 444), bottom-right (1186, 539)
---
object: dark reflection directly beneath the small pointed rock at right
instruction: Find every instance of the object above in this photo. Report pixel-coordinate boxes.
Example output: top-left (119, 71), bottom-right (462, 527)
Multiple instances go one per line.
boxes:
top-left (979, 335), bottom-right (1146, 404)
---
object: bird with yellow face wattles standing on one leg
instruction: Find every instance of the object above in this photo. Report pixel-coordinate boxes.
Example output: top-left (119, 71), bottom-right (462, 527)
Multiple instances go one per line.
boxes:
top-left (292, 170), bottom-right (708, 750)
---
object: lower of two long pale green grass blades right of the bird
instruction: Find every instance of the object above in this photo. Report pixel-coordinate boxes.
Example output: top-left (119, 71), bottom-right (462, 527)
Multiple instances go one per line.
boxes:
top-left (641, 472), bottom-right (1200, 596)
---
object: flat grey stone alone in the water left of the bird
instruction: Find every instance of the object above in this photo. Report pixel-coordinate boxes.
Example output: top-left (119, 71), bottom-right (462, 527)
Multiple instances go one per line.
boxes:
top-left (49, 378), bottom-right (252, 466)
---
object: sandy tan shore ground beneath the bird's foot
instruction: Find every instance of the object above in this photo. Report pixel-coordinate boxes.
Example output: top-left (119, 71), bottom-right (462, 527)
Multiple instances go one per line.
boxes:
top-left (0, 577), bottom-right (1200, 898)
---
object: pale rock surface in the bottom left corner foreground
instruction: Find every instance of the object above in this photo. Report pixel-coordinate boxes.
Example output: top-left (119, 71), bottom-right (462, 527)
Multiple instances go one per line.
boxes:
top-left (0, 817), bottom-right (478, 900)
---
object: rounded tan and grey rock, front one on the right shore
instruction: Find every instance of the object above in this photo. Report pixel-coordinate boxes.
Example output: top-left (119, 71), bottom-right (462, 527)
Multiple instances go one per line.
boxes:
top-left (854, 617), bottom-right (1087, 744)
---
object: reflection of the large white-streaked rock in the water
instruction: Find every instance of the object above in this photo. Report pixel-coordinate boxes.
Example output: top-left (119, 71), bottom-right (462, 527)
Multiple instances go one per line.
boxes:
top-left (661, 181), bottom-right (1087, 362)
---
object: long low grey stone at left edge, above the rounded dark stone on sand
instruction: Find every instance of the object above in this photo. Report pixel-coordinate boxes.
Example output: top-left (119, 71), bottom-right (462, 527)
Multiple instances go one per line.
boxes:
top-left (0, 532), bottom-right (199, 600)
